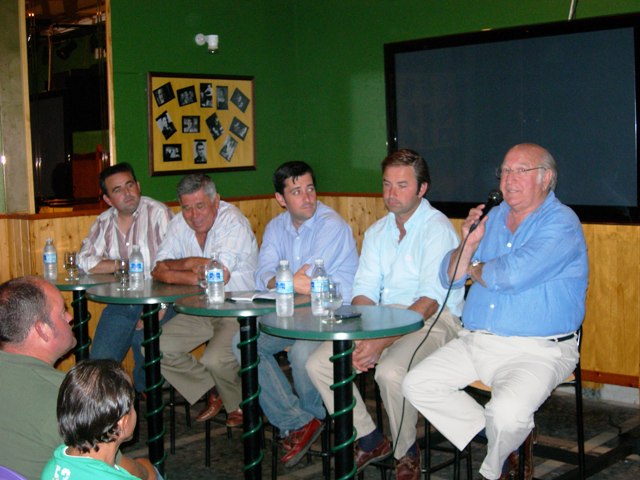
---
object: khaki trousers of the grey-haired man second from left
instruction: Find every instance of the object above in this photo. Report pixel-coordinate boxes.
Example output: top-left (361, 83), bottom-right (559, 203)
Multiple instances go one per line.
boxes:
top-left (160, 314), bottom-right (242, 412)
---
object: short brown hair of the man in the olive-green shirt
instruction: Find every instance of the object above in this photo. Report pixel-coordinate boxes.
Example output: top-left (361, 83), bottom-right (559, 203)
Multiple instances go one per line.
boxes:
top-left (0, 277), bottom-right (51, 345)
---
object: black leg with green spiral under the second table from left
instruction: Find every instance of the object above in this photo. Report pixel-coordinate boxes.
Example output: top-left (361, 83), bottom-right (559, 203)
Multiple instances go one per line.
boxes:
top-left (142, 305), bottom-right (167, 475)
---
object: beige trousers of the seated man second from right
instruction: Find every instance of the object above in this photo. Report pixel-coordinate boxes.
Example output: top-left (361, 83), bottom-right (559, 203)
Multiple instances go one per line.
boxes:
top-left (307, 309), bottom-right (461, 459)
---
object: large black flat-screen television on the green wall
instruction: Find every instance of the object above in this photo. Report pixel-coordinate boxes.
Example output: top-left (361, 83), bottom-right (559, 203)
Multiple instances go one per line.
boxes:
top-left (384, 14), bottom-right (640, 224)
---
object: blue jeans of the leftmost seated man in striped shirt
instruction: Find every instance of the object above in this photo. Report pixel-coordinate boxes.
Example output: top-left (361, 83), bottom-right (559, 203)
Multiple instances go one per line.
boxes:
top-left (90, 305), bottom-right (175, 392)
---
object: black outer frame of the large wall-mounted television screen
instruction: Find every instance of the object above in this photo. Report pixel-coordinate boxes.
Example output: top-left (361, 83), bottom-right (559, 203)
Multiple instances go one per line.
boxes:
top-left (384, 14), bottom-right (640, 225)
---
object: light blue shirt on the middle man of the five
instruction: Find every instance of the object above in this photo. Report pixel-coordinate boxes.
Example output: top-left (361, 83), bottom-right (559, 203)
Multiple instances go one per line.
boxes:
top-left (256, 202), bottom-right (358, 303)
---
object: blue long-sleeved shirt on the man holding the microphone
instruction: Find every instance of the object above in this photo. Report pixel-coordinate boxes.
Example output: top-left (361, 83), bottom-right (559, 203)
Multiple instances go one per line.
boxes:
top-left (440, 192), bottom-right (589, 337)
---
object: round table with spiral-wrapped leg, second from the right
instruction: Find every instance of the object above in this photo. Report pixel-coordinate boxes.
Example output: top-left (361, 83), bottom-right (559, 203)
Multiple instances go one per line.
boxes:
top-left (173, 292), bottom-right (309, 479)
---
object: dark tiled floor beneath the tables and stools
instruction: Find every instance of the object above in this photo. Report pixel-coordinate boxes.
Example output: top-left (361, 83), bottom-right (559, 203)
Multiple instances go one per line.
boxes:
top-left (125, 382), bottom-right (640, 480)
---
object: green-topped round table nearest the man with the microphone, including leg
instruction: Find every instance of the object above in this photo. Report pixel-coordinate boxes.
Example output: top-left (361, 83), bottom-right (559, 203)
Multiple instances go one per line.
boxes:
top-left (260, 305), bottom-right (424, 479)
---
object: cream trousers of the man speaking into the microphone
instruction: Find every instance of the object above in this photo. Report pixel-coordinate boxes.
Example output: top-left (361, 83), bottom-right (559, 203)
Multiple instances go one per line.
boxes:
top-left (403, 330), bottom-right (579, 479)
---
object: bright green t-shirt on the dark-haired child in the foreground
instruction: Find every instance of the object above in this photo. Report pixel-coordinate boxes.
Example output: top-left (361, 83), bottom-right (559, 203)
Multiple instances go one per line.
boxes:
top-left (40, 445), bottom-right (136, 480)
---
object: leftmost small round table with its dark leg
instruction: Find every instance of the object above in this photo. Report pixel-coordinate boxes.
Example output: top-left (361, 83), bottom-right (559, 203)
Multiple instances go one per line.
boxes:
top-left (53, 273), bottom-right (115, 363)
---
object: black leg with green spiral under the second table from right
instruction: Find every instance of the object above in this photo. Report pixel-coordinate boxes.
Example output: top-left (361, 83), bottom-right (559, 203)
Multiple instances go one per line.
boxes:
top-left (238, 317), bottom-right (264, 479)
